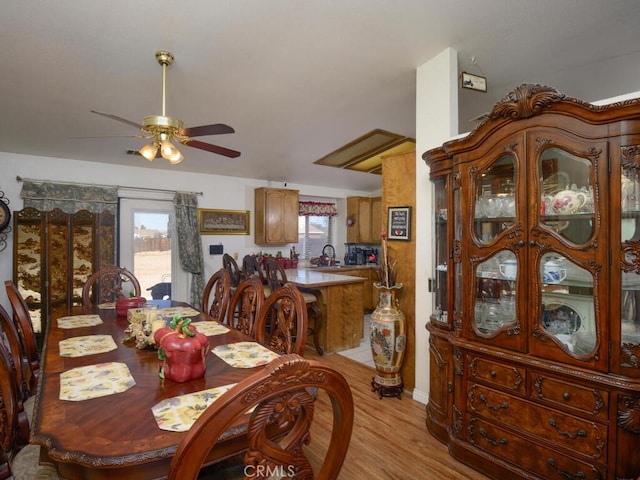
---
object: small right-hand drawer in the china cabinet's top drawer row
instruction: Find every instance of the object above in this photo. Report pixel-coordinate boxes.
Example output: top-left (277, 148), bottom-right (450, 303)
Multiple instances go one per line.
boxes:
top-left (532, 373), bottom-right (609, 420)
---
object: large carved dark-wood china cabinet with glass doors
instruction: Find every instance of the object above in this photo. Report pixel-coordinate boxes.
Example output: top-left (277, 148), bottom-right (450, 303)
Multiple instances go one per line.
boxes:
top-left (423, 85), bottom-right (640, 480)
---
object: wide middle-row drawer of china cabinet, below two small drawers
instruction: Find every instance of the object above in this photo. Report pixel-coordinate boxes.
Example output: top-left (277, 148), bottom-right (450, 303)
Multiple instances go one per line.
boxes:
top-left (468, 385), bottom-right (607, 462)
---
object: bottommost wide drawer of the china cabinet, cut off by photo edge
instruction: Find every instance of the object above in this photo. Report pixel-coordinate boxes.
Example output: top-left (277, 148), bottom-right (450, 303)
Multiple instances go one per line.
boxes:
top-left (467, 418), bottom-right (607, 480)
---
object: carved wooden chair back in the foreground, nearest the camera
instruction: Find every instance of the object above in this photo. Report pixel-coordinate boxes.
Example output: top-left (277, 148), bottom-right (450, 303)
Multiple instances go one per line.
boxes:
top-left (169, 355), bottom-right (354, 480)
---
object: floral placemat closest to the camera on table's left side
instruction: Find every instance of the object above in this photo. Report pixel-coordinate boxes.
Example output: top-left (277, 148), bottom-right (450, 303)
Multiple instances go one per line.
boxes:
top-left (60, 362), bottom-right (136, 401)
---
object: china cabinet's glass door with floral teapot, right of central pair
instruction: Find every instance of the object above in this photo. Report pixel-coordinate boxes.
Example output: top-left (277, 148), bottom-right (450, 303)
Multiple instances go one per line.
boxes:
top-left (527, 138), bottom-right (610, 368)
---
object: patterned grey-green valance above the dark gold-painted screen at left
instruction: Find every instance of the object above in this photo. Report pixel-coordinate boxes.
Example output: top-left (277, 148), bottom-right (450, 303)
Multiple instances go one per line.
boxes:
top-left (20, 180), bottom-right (118, 216)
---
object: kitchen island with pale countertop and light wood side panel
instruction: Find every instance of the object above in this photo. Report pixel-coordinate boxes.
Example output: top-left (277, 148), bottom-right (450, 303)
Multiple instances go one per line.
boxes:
top-left (285, 268), bottom-right (365, 353)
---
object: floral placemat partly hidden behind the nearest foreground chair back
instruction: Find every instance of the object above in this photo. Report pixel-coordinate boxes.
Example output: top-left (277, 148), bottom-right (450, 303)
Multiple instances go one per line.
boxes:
top-left (151, 383), bottom-right (235, 432)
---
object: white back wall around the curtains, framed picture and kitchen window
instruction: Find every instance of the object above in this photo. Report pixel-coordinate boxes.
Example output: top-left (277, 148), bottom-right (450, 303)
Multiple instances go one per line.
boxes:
top-left (0, 152), bottom-right (372, 307)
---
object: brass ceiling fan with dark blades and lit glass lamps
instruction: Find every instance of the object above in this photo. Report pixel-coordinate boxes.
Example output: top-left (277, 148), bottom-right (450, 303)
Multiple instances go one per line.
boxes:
top-left (91, 51), bottom-right (240, 165)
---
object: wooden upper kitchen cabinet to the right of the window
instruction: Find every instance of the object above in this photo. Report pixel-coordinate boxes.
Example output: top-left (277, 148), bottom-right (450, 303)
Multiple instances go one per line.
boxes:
top-left (347, 197), bottom-right (386, 243)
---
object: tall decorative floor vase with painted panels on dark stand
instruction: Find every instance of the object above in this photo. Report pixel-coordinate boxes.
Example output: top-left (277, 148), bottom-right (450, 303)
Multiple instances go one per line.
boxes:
top-left (369, 283), bottom-right (407, 398)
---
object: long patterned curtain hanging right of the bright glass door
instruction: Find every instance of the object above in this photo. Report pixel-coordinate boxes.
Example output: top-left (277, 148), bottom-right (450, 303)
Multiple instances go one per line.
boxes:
top-left (173, 192), bottom-right (204, 308)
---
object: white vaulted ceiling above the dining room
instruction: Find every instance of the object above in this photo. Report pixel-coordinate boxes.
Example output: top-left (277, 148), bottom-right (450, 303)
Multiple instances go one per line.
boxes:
top-left (0, 0), bottom-right (640, 190)
